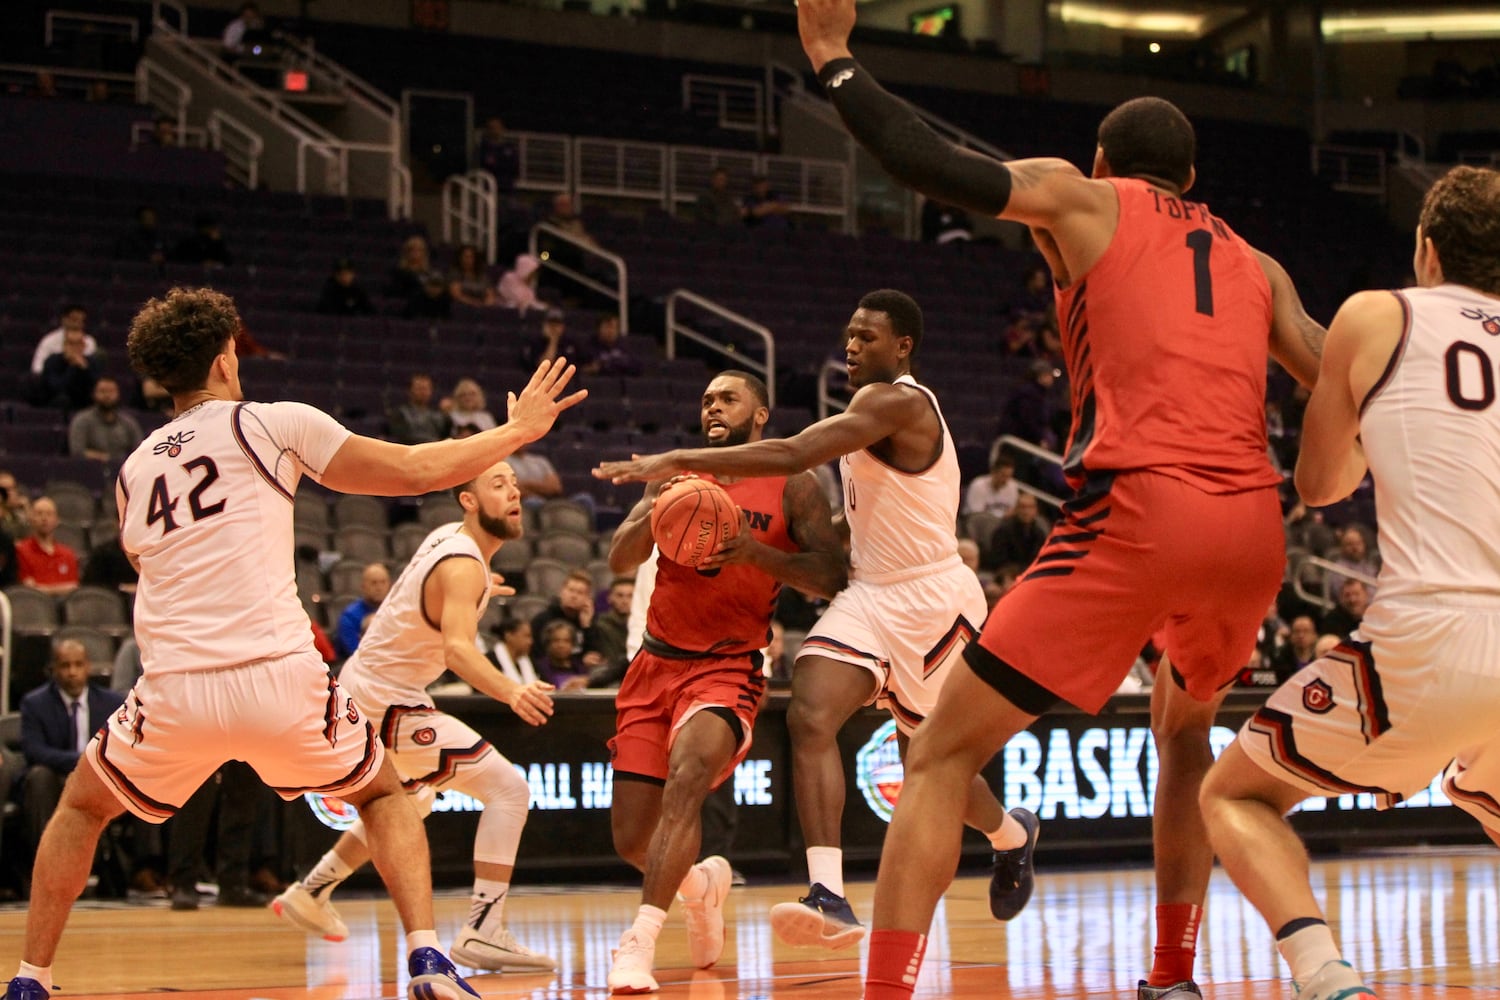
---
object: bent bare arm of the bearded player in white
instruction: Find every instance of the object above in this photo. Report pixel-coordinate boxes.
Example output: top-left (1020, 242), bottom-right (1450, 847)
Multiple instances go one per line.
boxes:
top-left (422, 559), bottom-right (552, 726)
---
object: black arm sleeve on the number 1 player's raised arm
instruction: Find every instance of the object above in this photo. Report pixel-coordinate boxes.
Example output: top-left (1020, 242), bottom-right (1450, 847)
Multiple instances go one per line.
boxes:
top-left (818, 58), bottom-right (1011, 216)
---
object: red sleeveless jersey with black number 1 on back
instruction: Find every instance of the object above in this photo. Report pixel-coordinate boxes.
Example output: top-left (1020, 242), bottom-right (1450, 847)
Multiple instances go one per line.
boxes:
top-left (1058, 178), bottom-right (1281, 493)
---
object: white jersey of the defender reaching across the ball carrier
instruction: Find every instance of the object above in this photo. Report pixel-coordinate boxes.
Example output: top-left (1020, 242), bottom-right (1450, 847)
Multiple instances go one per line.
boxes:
top-left (839, 375), bottom-right (962, 579)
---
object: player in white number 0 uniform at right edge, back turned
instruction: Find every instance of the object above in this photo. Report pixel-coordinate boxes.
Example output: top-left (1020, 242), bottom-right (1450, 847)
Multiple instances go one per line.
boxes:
top-left (1202, 166), bottom-right (1500, 1000)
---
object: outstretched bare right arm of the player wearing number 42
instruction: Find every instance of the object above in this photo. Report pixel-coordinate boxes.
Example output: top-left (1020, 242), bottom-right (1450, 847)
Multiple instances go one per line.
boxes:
top-left (320, 358), bottom-right (588, 496)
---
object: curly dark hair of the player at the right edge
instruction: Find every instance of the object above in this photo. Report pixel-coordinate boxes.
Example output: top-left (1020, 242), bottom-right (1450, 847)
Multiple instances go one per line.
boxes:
top-left (1418, 166), bottom-right (1500, 295)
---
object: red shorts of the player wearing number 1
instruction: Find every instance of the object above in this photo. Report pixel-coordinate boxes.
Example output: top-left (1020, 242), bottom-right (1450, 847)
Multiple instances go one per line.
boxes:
top-left (977, 472), bottom-right (1286, 712)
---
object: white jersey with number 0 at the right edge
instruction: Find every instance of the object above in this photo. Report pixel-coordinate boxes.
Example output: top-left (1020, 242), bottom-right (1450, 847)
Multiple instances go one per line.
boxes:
top-left (1359, 285), bottom-right (1500, 600)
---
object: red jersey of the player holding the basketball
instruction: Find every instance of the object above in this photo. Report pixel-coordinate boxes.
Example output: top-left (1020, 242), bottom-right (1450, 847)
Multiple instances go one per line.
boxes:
top-left (647, 475), bottom-right (798, 657)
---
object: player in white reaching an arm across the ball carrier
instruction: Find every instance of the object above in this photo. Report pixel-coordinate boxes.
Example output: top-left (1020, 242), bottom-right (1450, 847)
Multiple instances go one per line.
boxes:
top-left (596, 289), bottom-right (1038, 948)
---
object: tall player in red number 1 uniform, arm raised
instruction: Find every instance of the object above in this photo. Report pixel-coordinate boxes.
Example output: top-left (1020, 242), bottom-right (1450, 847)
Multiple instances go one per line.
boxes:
top-left (798, 0), bottom-right (1323, 1000)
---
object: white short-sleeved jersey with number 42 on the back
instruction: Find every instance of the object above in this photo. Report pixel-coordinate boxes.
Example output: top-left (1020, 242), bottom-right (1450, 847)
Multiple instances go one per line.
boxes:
top-left (116, 400), bottom-right (350, 675)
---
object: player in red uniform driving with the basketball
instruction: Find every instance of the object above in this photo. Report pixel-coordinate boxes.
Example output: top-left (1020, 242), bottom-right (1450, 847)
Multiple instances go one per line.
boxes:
top-left (609, 372), bottom-right (848, 993)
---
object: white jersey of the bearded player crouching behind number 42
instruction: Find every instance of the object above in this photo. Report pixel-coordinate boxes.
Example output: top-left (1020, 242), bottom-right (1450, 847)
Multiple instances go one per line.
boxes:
top-left (339, 522), bottom-right (489, 718)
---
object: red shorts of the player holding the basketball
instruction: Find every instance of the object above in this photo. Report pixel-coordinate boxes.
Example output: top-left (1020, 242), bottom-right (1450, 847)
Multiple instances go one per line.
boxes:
top-left (609, 649), bottom-right (765, 789)
